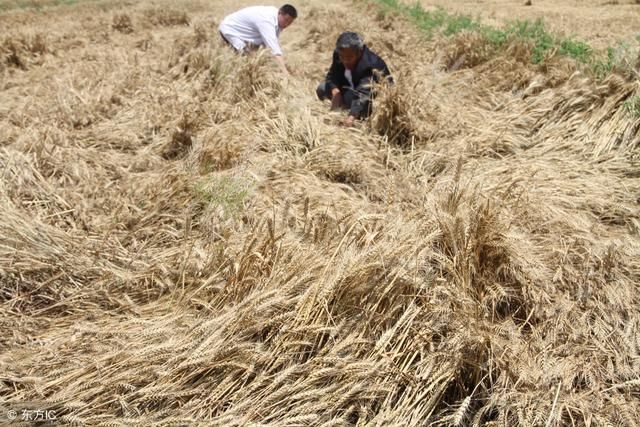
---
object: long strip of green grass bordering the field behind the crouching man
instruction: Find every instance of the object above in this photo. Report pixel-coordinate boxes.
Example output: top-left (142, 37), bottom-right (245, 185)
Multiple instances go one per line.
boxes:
top-left (370, 0), bottom-right (640, 78)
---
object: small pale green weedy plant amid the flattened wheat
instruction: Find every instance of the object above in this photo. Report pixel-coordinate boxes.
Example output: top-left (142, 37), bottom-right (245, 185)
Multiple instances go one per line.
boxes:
top-left (194, 176), bottom-right (254, 218)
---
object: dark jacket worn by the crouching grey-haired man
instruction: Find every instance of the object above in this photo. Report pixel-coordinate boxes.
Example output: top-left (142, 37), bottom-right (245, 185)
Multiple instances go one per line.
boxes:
top-left (326, 45), bottom-right (391, 117)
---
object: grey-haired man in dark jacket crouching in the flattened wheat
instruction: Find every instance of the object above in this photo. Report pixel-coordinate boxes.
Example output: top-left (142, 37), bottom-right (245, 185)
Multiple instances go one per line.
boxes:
top-left (316, 32), bottom-right (391, 126)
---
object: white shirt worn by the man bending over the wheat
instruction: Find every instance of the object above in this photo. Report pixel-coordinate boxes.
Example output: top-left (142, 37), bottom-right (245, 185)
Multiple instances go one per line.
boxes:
top-left (218, 6), bottom-right (282, 55)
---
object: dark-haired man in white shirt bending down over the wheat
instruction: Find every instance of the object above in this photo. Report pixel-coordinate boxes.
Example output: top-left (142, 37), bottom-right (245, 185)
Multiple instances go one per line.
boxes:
top-left (218, 4), bottom-right (298, 74)
